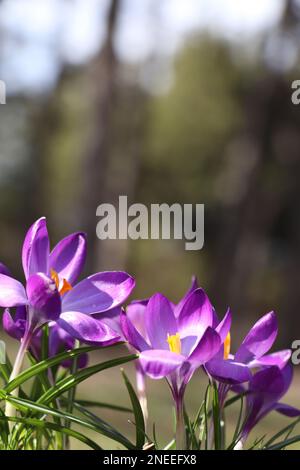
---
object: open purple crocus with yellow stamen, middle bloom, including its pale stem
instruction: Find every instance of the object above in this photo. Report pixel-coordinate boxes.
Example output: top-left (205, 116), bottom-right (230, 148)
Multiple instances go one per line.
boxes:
top-left (121, 288), bottom-right (230, 447)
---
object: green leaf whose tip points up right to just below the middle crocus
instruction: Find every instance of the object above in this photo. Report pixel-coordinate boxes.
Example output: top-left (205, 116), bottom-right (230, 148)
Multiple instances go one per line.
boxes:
top-left (38, 356), bottom-right (138, 404)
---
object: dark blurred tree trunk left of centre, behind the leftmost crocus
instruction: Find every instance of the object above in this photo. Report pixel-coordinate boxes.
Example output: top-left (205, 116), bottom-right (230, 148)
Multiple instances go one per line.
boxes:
top-left (80, 0), bottom-right (121, 268)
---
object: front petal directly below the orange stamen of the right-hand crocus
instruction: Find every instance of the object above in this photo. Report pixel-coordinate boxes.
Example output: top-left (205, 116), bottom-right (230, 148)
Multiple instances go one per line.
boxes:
top-left (205, 359), bottom-right (251, 385)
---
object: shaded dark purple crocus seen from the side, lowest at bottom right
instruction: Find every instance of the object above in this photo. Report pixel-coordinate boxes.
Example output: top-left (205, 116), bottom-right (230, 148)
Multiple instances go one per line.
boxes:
top-left (235, 364), bottom-right (300, 450)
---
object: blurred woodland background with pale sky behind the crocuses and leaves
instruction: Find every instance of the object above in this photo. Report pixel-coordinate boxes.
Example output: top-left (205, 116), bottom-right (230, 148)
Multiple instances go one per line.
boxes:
top-left (0, 0), bottom-right (300, 448)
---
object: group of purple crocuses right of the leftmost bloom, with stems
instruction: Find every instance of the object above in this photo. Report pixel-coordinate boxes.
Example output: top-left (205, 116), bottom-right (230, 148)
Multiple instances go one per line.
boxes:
top-left (121, 279), bottom-right (300, 448)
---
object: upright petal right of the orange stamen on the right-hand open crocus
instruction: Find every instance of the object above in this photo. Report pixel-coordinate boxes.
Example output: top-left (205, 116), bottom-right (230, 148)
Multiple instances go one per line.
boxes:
top-left (235, 312), bottom-right (278, 363)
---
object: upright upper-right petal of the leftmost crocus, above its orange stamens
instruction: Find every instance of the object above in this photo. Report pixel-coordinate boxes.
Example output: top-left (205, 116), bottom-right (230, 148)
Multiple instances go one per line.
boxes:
top-left (49, 233), bottom-right (86, 284)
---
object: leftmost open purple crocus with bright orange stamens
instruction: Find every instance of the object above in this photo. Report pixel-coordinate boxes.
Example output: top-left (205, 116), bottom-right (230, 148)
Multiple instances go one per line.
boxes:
top-left (0, 218), bottom-right (134, 345)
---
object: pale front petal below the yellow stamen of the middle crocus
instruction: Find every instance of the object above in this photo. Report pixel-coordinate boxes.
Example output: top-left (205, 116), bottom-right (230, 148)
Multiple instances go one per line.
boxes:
top-left (139, 349), bottom-right (185, 379)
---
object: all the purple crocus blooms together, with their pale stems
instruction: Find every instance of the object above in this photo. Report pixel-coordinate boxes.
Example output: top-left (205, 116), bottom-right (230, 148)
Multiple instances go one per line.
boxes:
top-left (0, 218), bottom-right (300, 448)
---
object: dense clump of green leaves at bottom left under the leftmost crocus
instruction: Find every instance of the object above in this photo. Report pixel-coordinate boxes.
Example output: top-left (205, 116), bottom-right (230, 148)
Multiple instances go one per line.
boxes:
top-left (0, 346), bottom-right (139, 450)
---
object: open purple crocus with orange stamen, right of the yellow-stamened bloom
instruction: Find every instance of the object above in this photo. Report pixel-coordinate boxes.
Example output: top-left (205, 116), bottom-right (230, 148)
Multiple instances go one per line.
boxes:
top-left (205, 312), bottom-right (291, 396)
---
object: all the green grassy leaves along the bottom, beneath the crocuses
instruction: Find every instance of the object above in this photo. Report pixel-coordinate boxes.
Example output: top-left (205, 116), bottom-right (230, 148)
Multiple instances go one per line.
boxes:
top-left (0, 344), bottom-right (300, 451)
